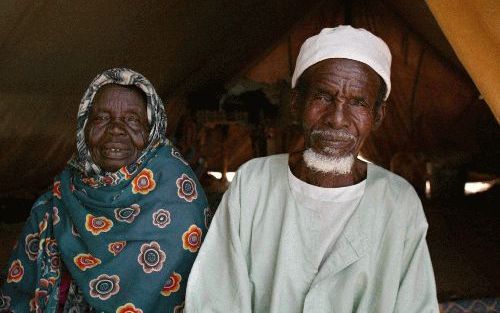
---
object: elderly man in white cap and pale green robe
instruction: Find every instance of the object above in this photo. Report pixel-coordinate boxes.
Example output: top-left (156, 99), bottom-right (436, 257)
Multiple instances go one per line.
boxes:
top-left (186, 26), bottom-right (438, 313)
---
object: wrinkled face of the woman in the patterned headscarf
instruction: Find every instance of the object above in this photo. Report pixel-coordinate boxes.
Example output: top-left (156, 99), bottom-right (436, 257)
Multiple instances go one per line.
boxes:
top-left (85, 85), bottom-right (149, 172)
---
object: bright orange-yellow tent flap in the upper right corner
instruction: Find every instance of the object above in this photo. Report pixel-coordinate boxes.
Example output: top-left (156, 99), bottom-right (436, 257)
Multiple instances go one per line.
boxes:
top-left (426, 0), bottom-right (500, 122)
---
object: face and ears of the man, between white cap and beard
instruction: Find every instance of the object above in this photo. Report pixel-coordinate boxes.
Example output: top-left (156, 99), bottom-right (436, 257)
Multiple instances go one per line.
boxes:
top-left (292, 59), bottom-right (385, 158)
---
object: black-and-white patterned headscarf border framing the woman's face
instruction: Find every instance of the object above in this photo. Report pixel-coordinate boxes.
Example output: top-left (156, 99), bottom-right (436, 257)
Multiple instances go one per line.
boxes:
top-left (69, 68), bottom-right (168, 176)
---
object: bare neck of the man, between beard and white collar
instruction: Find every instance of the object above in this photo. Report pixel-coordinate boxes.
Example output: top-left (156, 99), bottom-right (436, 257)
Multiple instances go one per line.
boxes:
top-left (288, 151), bottom-right (367, 188)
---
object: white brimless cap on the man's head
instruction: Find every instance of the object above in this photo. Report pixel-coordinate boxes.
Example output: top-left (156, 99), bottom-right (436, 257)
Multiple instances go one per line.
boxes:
top-left (292, 25), bottom-right (392, 100)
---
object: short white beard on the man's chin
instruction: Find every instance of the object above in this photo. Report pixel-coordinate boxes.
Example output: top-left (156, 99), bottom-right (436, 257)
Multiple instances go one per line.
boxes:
top-left (303, 148), bottom-right (354, 175)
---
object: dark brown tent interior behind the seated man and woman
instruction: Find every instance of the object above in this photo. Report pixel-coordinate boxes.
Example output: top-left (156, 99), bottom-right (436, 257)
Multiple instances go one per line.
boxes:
top-left (0, 0), bottom-right (500, 308)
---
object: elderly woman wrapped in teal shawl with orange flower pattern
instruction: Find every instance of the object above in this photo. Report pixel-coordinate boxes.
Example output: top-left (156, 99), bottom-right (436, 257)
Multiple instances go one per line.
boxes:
top-left (0, 68), bottom-right (208, 312)
